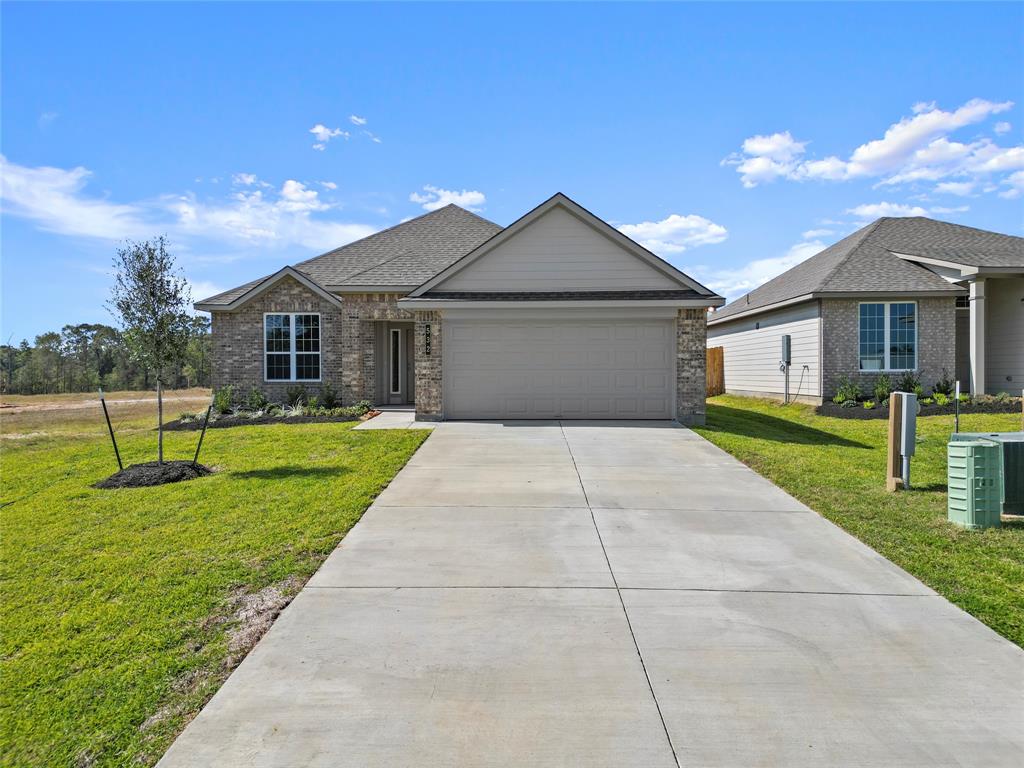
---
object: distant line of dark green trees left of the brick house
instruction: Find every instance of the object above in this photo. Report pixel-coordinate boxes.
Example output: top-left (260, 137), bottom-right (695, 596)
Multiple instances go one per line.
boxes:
top-left (0, 317), bottom-right (211, 394)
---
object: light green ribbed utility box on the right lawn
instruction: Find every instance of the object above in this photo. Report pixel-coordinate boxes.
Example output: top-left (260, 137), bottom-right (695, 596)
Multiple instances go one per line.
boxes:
top-left (946, 439), bottom-right (1002, 528)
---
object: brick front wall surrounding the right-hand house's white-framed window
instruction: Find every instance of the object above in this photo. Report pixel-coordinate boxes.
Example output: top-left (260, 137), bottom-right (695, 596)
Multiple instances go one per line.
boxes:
top-left (821, 297), bottom-right (956, 399)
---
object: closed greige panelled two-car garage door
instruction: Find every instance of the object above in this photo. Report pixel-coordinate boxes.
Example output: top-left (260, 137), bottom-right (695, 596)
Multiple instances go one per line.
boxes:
top-left (442, 319), bottom-right (676, 419)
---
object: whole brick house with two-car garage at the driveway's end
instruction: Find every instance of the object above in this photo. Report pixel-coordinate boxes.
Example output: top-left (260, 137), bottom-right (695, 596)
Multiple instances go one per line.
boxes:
top-left (196, 195), bottom-right (724, 424)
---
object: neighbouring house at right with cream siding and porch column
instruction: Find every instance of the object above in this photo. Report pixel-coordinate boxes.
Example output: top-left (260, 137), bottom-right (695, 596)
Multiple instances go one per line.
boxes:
top-left (708, 217), bottom-right (1024, 402)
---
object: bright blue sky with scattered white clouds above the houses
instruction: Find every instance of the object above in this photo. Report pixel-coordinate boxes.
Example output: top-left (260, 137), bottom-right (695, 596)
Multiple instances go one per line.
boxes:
top-left (0, 3), bottom-right (1024, 341)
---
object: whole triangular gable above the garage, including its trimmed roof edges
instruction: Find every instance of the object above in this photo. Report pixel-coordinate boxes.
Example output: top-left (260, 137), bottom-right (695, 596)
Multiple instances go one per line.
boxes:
top-left (410, 194), bottom-right (717, 298)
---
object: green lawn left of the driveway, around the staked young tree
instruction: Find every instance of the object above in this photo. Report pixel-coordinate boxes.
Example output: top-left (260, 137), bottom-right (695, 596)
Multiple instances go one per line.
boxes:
top-left (0, 393), bottom-right (426, 766)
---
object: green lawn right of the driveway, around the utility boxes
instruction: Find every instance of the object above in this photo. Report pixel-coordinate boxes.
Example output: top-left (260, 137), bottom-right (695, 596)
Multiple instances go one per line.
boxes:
top-left (697, 395), bottom-right (1024, 647)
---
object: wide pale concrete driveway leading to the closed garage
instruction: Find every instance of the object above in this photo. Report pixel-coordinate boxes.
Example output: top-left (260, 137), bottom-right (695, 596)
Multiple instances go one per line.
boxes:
top-left (161, 422), bottom-right (1024, 768)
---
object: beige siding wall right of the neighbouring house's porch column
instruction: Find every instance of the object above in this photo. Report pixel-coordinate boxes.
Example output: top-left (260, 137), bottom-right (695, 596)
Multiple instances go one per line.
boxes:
top-left (985, 278), bottom-right (1024, 394)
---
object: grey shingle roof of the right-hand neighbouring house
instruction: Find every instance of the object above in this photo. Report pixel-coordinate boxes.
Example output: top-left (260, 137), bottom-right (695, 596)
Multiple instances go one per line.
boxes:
top-left (709, 216), bottom-right (1024, 323)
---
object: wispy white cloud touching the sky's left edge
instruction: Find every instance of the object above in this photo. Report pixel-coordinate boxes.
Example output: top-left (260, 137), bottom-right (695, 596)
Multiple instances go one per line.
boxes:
top-left (0, 155), bottom-right (151, 240)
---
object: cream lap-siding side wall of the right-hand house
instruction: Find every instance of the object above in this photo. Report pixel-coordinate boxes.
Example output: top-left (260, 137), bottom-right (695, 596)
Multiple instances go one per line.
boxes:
top-left (708, 301), bottom-right (821, 400)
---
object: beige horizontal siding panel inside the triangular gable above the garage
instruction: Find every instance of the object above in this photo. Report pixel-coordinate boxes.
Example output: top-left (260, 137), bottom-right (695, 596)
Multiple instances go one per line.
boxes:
top-left (444, 208), bottom-right (679, 291)
